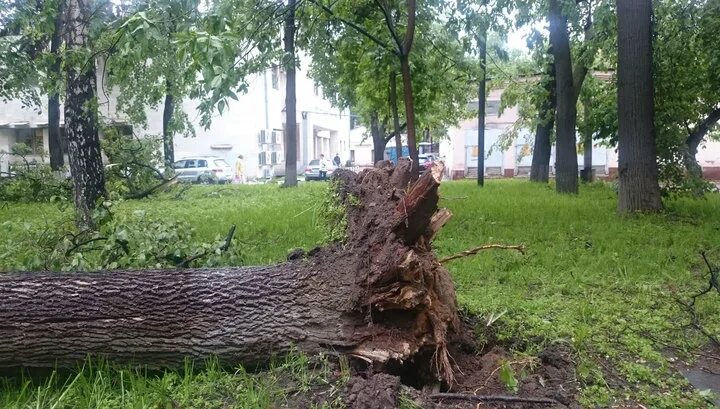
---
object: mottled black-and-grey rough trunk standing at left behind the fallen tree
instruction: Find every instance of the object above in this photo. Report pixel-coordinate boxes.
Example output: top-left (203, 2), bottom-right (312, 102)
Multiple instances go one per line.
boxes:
top-left (65, 0), bottom-right (105, 227)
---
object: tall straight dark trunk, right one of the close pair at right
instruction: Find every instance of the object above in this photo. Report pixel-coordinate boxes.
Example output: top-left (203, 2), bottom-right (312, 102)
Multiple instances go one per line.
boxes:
top-left (549, 0), bottom-right (578, 193)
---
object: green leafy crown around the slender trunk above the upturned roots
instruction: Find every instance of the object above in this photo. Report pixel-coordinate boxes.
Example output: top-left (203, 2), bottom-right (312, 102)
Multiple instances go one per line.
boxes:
top-left (299, 1), bottom-right (477, 140)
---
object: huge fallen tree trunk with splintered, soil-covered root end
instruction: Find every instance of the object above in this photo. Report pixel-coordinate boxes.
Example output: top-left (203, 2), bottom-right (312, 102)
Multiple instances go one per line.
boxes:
top-left (0, 162), bottom-right (459, 381)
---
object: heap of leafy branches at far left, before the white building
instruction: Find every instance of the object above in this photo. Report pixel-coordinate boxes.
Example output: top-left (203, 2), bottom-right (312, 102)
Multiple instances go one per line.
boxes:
top-left (0, 143), bottom-right (72, 202)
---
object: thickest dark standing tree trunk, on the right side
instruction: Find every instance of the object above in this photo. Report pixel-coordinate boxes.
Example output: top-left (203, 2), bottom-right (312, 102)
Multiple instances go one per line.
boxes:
top-left (616, 0), bottom-right (662, 214)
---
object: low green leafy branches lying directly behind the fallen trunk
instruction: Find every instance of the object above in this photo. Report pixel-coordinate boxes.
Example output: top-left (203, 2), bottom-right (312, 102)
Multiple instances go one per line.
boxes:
top-left (0, 201), bottom-right (242, 271)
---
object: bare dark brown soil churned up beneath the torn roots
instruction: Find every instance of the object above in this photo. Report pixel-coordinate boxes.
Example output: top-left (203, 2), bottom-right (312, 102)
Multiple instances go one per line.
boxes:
top-left (282, 334), bottom-right (580, 409)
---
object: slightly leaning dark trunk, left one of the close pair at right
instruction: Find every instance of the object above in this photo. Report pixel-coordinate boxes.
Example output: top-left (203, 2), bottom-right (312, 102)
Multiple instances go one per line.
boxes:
top-left (530, 59), bottom-right (556, 183)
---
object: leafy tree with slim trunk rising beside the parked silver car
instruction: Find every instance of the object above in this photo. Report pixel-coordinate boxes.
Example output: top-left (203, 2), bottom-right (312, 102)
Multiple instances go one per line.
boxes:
top-left (99, 0), bottom-right (200, 170)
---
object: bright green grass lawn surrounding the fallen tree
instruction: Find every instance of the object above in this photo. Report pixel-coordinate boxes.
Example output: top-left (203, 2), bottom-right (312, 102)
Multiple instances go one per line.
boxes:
top-left (0, 180), bottom-right (720, 408)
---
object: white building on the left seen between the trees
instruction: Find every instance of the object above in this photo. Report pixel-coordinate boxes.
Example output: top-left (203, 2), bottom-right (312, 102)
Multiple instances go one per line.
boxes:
top-left (0, 56), bottom-right (350, 179)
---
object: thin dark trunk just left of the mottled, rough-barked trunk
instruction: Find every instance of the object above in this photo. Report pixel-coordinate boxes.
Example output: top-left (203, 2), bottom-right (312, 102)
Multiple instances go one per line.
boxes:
top-left (48, 6), bottom-right (65, 171)
